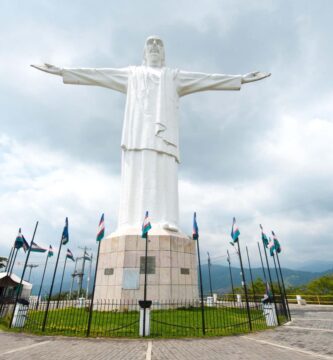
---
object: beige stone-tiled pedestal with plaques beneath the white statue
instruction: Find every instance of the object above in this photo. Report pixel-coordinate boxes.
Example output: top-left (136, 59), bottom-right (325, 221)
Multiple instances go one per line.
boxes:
top-left (95, 233), bottom-right (198, 301)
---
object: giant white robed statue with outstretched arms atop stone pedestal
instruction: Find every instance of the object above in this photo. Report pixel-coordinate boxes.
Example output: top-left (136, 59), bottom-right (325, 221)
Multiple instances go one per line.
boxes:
top-left (32, 36), bottom-right (270, 233)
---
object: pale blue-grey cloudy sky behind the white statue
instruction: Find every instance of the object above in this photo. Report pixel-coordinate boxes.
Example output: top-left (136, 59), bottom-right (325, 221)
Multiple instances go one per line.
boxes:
top-left (0, 0), bottom-right (333, 278)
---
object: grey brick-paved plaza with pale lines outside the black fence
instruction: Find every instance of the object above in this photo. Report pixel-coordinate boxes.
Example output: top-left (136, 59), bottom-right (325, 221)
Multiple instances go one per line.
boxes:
top-left (0, 305), bottom-right (333, 360)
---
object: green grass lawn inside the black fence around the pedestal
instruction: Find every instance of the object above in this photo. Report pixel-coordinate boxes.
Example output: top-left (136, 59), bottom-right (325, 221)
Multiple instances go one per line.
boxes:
top-left (19, 307), bottom-right (267, 338)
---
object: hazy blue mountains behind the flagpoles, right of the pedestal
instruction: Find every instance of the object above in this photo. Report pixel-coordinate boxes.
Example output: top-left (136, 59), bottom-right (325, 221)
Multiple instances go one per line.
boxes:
top-left (198, 264), bottom-right (331, 293)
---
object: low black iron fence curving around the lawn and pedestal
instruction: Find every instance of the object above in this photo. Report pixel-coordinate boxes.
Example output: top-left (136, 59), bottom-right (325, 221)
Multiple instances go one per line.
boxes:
top-left (3, 297), bottom-right (288, 337)
